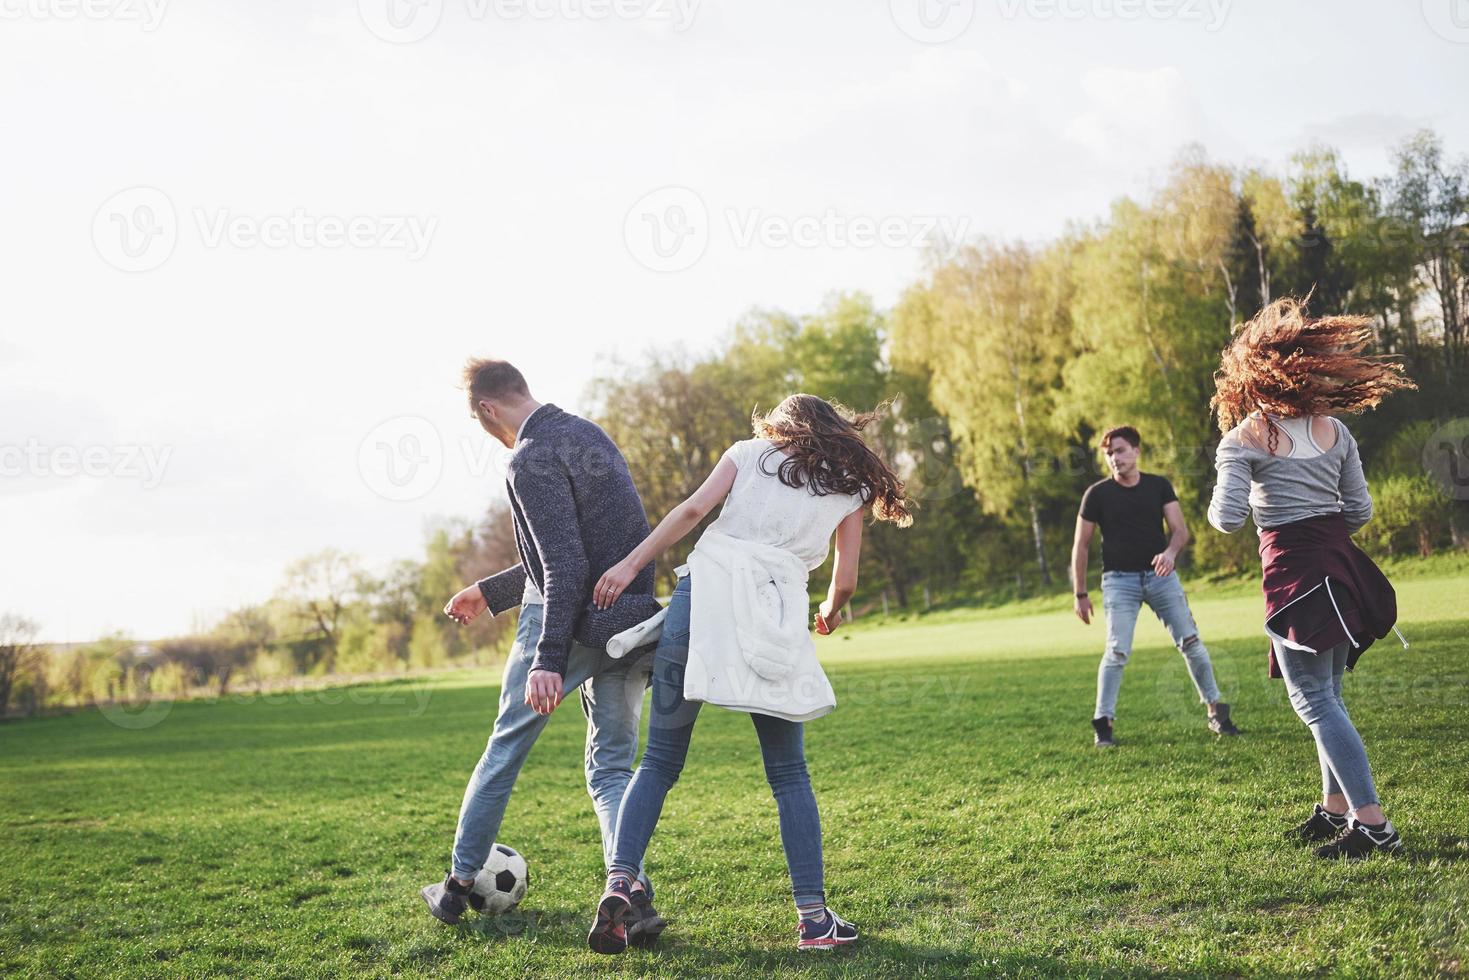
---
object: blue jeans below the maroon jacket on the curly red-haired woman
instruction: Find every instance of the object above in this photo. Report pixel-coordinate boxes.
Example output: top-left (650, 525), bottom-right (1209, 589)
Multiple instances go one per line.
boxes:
top-left (1275, 642), bottom-right (1378, 810)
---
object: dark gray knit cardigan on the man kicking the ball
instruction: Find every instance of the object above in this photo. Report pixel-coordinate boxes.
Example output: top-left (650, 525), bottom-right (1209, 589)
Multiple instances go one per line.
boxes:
top-left (479, 404), bottom-right (661, 674)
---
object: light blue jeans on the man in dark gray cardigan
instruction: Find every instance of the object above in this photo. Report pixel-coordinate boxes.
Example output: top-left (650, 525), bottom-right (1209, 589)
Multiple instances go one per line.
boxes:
top-left (454, 604), bottom-right (652, 879)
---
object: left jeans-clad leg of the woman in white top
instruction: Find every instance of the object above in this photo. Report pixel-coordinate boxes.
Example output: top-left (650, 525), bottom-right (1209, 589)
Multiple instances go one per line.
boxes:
top-left (608, 577), bottom-right (701, 880)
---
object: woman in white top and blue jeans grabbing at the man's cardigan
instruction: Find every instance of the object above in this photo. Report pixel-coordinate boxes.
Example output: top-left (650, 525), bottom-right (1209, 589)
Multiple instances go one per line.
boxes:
top-left (588, 395), bottom-right (912, 954)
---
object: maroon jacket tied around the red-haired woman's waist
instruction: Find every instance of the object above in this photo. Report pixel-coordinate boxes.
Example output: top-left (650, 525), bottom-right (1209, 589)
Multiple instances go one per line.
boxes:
top-left (1260, 514), bottom-right (1406, 677)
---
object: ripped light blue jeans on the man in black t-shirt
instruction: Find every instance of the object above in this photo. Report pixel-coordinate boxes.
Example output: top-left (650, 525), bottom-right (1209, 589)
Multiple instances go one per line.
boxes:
top-left (1091, 570), bottom-right (1219, 718)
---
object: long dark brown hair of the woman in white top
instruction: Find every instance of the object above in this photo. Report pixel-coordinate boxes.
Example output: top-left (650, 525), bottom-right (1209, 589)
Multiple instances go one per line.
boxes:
top-left (751, 394), bottom-right (914, 527)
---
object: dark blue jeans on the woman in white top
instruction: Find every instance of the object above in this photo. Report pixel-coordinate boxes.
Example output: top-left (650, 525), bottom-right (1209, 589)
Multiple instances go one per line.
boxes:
top-left (613, 576), bottom-right (826, 905)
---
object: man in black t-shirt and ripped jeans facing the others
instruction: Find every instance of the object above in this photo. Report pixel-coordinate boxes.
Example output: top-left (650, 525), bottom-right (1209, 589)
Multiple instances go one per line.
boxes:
top-left (1071, 426), bottom-right (1240, 746)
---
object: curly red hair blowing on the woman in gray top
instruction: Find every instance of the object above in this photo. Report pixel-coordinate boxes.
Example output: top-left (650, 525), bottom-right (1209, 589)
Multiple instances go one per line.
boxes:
top-left (1209, 297), bottom-right (1418, 454)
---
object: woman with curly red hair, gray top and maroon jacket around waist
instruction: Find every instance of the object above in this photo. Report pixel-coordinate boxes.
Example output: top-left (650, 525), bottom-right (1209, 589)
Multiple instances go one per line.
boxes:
top-left (1209, 298), bottom-right (1415, 858)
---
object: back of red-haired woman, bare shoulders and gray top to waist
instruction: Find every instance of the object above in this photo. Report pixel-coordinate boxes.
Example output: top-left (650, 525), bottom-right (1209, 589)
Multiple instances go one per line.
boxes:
top-left (1209, 411), bottom-right (1372, 532)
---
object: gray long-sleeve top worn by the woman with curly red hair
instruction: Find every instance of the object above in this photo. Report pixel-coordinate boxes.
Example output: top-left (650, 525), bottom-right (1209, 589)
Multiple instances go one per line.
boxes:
top-left (1209, 419), bottom-right (1372, 533)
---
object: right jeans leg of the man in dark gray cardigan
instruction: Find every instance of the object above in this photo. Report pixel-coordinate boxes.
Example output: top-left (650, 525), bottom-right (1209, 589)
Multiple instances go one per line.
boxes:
top-left (582, 648), bottom-right (654, 870)
